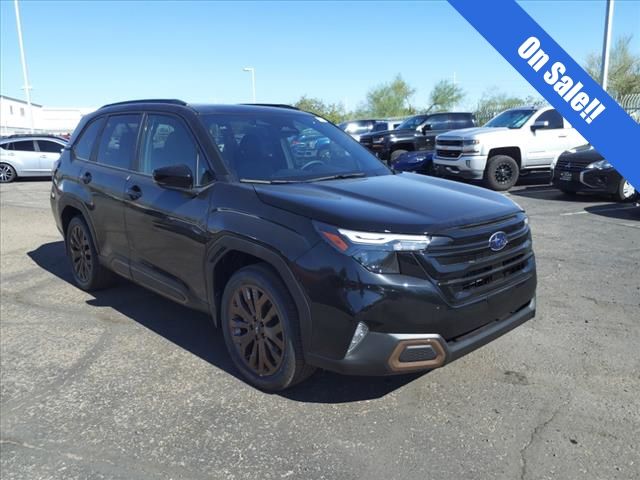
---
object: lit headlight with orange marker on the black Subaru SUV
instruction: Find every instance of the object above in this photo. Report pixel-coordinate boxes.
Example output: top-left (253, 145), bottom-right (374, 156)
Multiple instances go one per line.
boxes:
top-left (313, 222), bottom-right (433, 273)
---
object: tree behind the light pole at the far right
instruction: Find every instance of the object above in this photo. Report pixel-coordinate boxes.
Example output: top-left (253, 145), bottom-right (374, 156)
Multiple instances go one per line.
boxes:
top-left (584, 35), bottom-right (640, 98)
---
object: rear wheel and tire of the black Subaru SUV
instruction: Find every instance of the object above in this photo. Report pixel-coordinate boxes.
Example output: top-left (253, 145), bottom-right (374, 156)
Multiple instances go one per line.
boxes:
top-left (65, 216), bottom-right (116, 292)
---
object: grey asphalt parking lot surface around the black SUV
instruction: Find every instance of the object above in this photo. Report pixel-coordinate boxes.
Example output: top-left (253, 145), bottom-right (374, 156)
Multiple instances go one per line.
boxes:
top-left (0, 177), bottom-right (640, 480)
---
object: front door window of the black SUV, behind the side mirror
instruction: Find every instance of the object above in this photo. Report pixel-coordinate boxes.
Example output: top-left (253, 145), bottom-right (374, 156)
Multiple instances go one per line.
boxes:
top-left (138, 115), bottom-right (213, 185)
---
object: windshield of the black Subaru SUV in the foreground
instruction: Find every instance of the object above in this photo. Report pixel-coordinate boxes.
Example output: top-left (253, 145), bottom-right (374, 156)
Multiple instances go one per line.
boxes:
top-left (203, 112), bottom-right (391, 183)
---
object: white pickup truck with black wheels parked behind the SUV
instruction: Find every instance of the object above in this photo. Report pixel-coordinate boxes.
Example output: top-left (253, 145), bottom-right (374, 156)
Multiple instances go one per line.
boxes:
top-left (433, 107), bottom-right (587, 191)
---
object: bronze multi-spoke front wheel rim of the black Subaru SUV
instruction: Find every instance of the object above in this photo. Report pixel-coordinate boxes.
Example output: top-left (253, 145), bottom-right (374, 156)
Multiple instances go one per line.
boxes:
top-left (228, 285), bottom-right (285, 377)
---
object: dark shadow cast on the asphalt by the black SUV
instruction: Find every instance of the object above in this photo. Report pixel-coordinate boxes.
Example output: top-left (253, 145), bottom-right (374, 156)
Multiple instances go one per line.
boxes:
top-left (27, 241), bottom-right (424, 403)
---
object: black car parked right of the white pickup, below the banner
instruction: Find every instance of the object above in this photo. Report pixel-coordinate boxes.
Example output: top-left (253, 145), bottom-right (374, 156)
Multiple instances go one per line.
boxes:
top-left (551, 144), bottom-right (638, 202)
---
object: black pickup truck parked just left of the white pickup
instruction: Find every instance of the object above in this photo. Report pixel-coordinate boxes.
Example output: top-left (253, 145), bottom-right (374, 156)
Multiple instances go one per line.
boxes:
top-left (360, 112), bottom-right (476, 163)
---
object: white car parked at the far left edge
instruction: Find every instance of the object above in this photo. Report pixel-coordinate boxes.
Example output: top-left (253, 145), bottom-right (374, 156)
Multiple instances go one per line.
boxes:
top-left (0, 135), bottom-right (67, 183)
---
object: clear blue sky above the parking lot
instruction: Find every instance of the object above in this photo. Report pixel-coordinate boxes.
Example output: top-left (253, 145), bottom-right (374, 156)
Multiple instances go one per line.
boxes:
top-left (0, 0), bottom-right (640, 108)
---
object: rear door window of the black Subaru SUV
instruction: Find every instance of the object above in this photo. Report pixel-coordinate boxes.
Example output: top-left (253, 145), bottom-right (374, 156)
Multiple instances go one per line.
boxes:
top-left (97, 114), bottom-right (142, 169)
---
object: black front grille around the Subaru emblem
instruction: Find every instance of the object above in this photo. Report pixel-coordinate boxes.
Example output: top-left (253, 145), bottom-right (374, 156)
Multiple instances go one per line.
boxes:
top-left (417, 214), bottom-right (533, 303)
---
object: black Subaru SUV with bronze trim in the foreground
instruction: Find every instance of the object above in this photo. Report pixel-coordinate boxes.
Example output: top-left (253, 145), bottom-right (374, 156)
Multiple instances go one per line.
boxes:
top-left (51, 100), bottom-right (536, 390)
